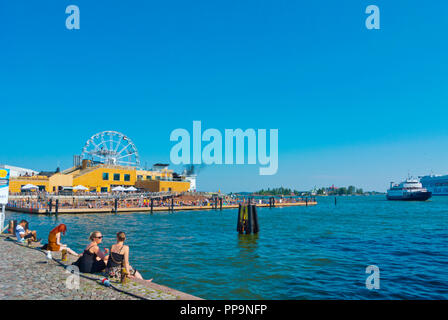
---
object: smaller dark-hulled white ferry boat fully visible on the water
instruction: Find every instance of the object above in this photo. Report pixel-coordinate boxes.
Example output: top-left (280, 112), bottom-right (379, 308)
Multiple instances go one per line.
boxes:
top-left (387, 179), bottom-right (432, 201)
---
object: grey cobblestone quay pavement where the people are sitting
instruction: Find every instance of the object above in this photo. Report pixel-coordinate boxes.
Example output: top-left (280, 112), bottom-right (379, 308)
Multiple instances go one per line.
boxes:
top-left (0, 235), bottom-right (200, 300)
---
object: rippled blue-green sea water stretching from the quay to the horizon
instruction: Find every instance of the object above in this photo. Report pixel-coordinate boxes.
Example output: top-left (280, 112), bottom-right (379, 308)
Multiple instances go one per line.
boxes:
top-left (6, 196), bottom-right (448, 299)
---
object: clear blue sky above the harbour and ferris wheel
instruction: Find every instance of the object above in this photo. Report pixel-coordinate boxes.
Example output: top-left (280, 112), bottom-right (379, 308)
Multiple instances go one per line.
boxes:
top-left (0, 0), bottom-right (448, 191)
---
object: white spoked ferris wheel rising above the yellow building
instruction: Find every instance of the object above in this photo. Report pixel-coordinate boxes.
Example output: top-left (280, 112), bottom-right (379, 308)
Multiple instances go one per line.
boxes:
top-left (81, 131), bottom-right (140, 167)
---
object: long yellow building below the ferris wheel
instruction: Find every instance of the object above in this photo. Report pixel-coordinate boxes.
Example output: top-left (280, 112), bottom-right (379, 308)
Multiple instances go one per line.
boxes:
top-left (10, 161), bottom-right (190, 192)
